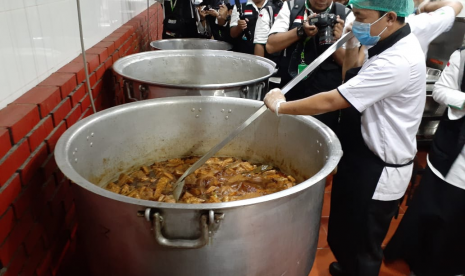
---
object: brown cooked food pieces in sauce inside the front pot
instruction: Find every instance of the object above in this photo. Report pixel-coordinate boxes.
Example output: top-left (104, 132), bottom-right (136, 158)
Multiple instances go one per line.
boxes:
top-left (106, 157), bottom-right (296, 203)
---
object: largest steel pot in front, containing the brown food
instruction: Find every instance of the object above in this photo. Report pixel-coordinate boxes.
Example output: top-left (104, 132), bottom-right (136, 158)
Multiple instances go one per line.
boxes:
top-left (55, 97), bottom-right (342, 276)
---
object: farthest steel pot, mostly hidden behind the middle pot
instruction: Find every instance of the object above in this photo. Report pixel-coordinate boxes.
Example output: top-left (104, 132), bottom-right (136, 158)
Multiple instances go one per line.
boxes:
top-left (150, 38), bottom-right (232, 51)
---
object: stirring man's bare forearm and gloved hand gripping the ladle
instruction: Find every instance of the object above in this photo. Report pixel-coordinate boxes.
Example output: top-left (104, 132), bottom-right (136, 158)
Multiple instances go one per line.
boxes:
top-left (265, 89), bottom-right (350, 115)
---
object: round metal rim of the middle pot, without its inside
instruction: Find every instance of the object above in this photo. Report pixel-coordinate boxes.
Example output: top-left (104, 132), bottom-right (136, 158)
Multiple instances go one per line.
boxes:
top-left (112, 50), bottom-right (276, 90)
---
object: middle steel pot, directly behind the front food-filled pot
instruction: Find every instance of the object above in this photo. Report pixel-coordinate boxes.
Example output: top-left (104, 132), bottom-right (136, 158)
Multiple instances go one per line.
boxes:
top-left (113, 50), bottom-right (276, 100)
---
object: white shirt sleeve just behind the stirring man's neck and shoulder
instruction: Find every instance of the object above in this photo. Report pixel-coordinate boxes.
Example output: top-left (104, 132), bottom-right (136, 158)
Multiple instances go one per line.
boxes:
top-left (406, 6), bottom-right (455, 56)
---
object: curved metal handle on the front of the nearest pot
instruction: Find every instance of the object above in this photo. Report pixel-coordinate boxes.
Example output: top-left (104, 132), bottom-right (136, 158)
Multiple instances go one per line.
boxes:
top-left (146, 209), bottom-right (224, 249)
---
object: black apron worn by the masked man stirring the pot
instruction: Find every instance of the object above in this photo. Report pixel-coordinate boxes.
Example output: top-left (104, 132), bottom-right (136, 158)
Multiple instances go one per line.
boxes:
top-left (328, 25), bottom-right (413, 276)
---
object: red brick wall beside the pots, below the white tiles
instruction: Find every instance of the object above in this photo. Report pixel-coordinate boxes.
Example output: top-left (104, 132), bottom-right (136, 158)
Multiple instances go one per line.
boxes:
top-left (0, 4), bottom-right (162, 276)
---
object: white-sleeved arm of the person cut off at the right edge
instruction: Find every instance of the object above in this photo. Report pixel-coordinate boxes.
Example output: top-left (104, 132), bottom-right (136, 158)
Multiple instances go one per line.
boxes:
top-left (433, 51), bottom-right (465, 109)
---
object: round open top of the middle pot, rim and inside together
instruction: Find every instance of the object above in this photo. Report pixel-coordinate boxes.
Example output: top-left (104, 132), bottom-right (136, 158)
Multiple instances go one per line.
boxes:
top-left (113, 50), bottom-right (276, 90)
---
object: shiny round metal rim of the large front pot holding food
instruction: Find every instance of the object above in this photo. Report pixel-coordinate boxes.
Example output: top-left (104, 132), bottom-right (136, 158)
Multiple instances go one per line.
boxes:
top-left (55, 96), bottom-right (342, 210)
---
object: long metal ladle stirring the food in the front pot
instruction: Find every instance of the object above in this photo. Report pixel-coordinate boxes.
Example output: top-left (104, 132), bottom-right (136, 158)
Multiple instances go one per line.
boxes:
top-left (173, 32), bottom-right (354, 202)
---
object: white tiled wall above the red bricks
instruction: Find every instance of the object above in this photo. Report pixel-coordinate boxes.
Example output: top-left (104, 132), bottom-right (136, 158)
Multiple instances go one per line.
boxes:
top-left (0, 0), bottom-right (155, 108)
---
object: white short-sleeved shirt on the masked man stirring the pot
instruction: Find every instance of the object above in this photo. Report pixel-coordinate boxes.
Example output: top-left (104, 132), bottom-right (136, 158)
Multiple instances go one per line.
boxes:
top-left (338, 34), bottom-right (426, 201)
